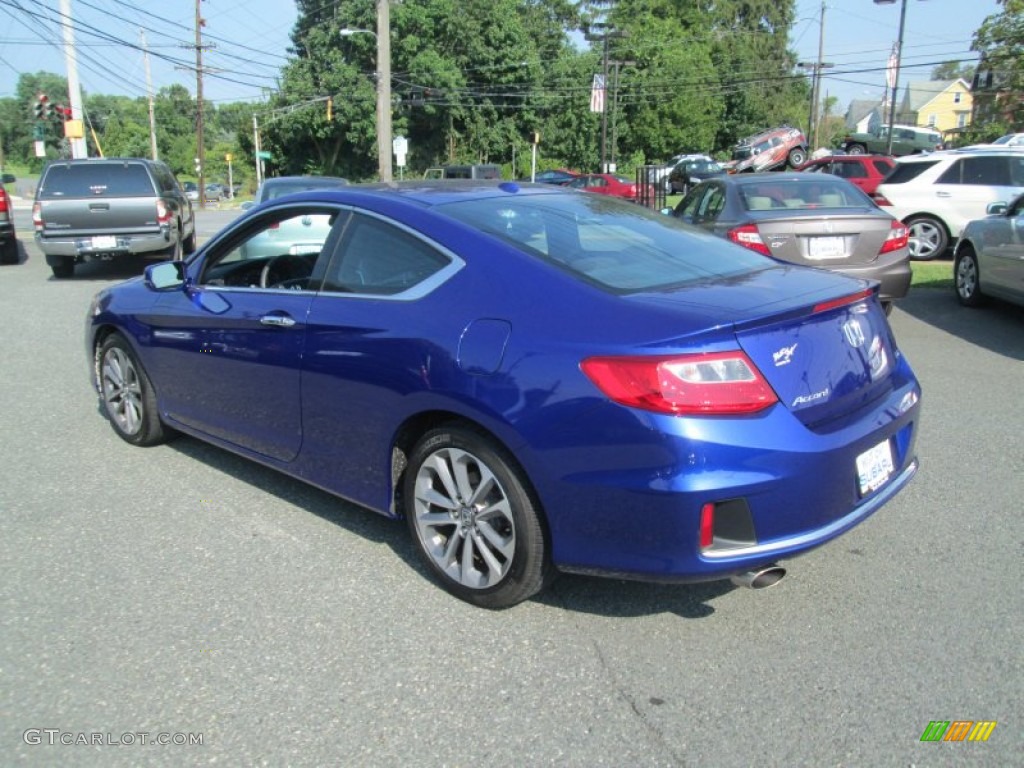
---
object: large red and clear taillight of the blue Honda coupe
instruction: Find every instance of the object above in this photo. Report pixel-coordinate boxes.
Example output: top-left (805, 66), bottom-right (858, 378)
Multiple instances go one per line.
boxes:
top-left (581, 350), bottom-right (778, 416)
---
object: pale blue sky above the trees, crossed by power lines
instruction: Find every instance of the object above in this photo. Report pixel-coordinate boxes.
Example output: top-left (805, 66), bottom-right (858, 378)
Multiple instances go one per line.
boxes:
top-left (0, 0), bottom-right (1000, 113)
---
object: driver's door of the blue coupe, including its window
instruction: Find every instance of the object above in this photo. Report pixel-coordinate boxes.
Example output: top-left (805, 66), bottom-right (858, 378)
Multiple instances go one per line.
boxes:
top-left (140, 203), bottom-right (347, 462)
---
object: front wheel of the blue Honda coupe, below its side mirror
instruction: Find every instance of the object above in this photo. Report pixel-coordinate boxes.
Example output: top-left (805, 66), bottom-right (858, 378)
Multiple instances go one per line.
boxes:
top-left (96, 334), bottom-right (167, 446)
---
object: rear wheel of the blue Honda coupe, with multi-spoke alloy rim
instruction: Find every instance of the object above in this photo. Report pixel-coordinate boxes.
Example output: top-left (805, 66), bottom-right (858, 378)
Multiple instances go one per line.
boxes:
top-left (402, 426), bottom-right (553, 608)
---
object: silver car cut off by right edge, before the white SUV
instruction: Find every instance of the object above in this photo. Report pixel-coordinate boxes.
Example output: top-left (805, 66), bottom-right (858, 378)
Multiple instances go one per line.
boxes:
top-left (953, 195), bottom-right (1024, 306)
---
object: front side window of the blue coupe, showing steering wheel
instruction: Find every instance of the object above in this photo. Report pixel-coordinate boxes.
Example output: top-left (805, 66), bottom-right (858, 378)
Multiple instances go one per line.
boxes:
top-left (199, 206), bottom-right (338, 291)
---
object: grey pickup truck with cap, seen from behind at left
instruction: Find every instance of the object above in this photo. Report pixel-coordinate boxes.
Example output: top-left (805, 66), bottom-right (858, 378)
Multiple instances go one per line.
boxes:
top-left (32, 158), bottom-right (196, 278)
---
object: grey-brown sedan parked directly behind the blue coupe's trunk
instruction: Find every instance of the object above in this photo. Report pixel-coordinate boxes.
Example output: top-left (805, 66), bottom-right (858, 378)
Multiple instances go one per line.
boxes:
top-left (674, 173), bottom-right (910, 310)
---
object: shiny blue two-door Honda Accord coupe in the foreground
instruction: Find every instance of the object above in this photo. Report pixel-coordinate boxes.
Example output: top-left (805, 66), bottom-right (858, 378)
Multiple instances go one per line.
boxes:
top-left (86, 181), bottom-right (921, 608)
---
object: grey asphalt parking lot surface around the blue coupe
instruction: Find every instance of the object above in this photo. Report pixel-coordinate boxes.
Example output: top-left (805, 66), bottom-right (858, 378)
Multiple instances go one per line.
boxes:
top-left (0, 209), bottom-right (1024, 767)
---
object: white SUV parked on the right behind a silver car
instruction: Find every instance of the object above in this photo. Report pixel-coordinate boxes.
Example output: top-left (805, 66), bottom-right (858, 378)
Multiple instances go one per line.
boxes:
top-left (874, 146), bottom-right (1024, 260)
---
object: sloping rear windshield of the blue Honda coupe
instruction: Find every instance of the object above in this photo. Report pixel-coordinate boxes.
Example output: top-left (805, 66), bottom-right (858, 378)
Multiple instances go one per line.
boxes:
top-left (438, 193), bottom-right (773, 293)
